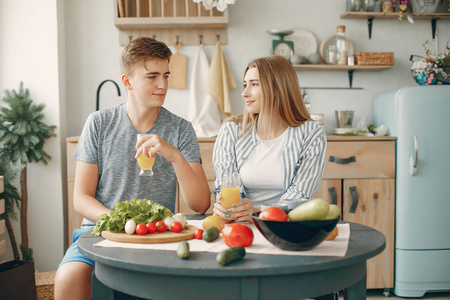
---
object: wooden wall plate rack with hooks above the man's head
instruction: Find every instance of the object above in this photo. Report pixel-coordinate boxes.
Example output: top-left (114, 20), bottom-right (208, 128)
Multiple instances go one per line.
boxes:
top-left (113, 0), bottom-right (228, 46)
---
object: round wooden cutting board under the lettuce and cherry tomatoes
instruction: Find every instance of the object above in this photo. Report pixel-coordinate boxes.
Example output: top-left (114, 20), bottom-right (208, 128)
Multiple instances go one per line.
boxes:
top-left (102, 225), bottom-right (197, 244)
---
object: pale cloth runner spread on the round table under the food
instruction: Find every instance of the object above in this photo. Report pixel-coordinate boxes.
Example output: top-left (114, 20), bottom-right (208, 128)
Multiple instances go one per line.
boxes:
top-left (94, 220), bottom-right (350, 256)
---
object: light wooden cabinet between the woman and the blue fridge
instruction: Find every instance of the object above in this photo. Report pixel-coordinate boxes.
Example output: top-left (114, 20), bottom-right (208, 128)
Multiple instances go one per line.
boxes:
top-left (313, 137), bottom-right (395, 289)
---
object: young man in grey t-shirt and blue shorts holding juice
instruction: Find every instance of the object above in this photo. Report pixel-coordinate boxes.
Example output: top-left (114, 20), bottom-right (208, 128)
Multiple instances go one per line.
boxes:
top-left (55, 38), bottom-right (210, 300)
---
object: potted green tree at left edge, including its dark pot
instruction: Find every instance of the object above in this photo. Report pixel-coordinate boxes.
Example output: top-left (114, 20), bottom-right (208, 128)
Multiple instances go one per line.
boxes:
top-left (0, 82), bottom-right (56, 299)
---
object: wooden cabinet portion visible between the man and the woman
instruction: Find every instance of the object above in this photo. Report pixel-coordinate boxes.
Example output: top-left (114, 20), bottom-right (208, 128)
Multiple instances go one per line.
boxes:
top-left (175, 138), bottom-right (216, 214)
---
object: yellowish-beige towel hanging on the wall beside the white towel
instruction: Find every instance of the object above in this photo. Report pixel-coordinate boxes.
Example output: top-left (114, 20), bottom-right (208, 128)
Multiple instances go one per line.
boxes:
top-left (206, 42), bottom-right (236, 117)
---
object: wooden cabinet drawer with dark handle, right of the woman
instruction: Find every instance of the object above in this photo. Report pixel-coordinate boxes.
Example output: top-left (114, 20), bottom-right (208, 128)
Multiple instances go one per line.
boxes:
top-left (323, 141), bottom-right (395, 179)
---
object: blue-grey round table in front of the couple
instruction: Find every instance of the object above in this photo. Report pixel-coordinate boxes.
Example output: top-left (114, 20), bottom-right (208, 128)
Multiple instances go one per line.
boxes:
top-left (79, 215), bottom-right (386, 300)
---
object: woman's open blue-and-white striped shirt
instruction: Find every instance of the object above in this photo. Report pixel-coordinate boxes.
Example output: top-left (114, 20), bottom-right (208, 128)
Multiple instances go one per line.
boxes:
top-left (213, 121), bottom-right (327, 200)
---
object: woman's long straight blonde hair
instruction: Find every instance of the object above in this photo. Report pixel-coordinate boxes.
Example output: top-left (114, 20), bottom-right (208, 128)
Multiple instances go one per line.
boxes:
top-left (228, 55), bottom-right (311, 133)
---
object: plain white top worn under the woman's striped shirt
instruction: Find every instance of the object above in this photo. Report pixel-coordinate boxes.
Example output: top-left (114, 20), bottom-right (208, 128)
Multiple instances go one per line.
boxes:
top-left (240, 130), bottom-right (288, 205)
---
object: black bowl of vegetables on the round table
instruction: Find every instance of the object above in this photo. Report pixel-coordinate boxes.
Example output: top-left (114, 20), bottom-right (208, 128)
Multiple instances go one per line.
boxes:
top-left (252, 213), bottom-right (339, 251)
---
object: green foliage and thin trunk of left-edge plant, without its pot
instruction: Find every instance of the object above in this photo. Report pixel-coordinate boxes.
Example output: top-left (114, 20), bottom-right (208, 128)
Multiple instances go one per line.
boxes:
top-left (0, 82), bottom-right (56, 261)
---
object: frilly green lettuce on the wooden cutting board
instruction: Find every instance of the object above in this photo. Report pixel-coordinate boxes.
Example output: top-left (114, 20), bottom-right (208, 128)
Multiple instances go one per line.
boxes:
top-left (92, 198), bottom-right (173, 236)
